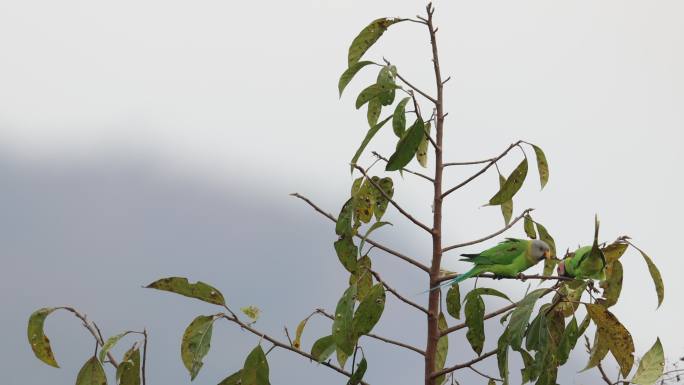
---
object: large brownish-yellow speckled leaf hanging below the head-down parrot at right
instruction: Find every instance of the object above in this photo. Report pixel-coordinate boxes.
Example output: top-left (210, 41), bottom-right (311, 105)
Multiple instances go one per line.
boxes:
top-left (585, 304), bottom-right (634, 377)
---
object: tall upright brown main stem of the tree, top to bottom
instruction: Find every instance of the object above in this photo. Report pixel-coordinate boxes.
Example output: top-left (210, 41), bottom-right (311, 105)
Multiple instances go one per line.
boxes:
top-left (425, 3), bottom-right (444, 385)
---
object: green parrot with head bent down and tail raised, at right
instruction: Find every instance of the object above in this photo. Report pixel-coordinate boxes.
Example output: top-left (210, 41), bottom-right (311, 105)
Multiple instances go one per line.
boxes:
top-left (558, 218), bottom-right (606, 281)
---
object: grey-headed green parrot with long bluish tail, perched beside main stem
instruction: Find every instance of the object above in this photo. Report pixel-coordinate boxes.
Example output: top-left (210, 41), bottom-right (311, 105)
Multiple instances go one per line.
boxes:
top-left (435, 238), bottom-right (551, 289)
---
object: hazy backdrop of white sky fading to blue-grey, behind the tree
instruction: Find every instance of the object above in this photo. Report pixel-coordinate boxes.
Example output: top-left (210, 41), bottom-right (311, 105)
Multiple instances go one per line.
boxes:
top-left (0, 0), bottom-right (684, 385)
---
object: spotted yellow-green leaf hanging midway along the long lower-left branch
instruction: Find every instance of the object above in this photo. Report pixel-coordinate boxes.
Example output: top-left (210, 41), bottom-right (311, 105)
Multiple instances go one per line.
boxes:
top-left (181, 315), bottom-right (214, 381)
